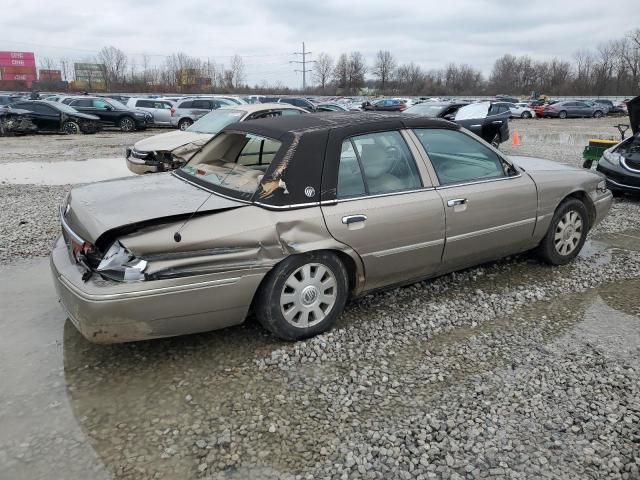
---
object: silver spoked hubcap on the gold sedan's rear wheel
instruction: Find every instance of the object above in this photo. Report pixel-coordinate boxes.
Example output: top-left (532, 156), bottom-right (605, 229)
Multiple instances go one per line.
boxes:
top-left (280, 263), bottom-right (338, 328)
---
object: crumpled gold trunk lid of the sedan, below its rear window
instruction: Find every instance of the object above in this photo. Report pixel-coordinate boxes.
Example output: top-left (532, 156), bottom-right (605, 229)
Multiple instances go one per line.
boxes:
top-left (62, 173), bottom-right (245, 244)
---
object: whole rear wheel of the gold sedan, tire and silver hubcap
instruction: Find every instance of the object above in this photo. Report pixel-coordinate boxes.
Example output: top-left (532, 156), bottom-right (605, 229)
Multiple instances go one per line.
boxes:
top-left (256, 252), bottom-right (349, 340)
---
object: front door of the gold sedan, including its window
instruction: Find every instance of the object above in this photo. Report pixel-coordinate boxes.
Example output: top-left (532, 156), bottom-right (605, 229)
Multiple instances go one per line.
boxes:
top-left (414, 129), bottom-right (538, 270)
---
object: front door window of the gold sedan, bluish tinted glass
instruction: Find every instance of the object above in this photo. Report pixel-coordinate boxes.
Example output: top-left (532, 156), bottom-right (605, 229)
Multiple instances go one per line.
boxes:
top-left (414, 129), bottom-right (506, 185)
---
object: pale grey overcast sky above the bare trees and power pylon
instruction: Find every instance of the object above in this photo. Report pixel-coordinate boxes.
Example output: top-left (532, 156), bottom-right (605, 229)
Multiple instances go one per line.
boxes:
top-left (0, 0), bottom-right (640, 86)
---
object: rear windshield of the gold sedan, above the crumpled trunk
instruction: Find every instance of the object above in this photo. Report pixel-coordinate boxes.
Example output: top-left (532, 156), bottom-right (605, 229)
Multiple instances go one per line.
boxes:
top-left (180, 132), bottom-right (282, 200)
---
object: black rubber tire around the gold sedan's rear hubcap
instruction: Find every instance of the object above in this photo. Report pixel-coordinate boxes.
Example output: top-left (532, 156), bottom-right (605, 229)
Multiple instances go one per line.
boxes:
top-left (255, 251), bottom-right (349, 340)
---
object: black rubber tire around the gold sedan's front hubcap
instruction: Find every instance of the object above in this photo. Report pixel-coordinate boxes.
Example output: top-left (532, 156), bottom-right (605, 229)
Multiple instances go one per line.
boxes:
top-left (537, 198), bottom-right (589, 265)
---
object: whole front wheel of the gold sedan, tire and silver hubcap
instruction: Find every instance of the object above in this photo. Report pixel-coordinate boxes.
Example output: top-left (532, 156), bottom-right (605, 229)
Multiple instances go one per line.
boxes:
top-left (538, 198), bottom-right (589, 265)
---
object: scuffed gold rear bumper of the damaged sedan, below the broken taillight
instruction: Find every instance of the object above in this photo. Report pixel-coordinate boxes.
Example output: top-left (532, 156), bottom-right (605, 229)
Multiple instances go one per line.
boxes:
top-left (50, 237), bottom-right (265, 343)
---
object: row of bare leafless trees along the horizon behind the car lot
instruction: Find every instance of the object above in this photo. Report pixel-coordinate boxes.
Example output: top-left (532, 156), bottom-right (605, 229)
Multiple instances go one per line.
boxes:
top-left (40, 29), bottom-right (640, 96)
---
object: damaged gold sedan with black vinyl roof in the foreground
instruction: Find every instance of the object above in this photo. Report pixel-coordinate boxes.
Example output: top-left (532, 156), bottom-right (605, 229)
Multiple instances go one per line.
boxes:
top-left (51, 113), bottom-right (611, 343)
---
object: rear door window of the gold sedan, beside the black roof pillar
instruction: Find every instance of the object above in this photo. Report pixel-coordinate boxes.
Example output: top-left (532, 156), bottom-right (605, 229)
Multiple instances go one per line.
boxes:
top-left (338, 131), bottom-right (422, 198)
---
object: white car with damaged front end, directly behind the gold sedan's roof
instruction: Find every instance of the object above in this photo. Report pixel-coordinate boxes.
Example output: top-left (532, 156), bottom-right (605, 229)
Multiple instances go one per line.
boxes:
top-left (126, 103), bottom-right (307, 174)
